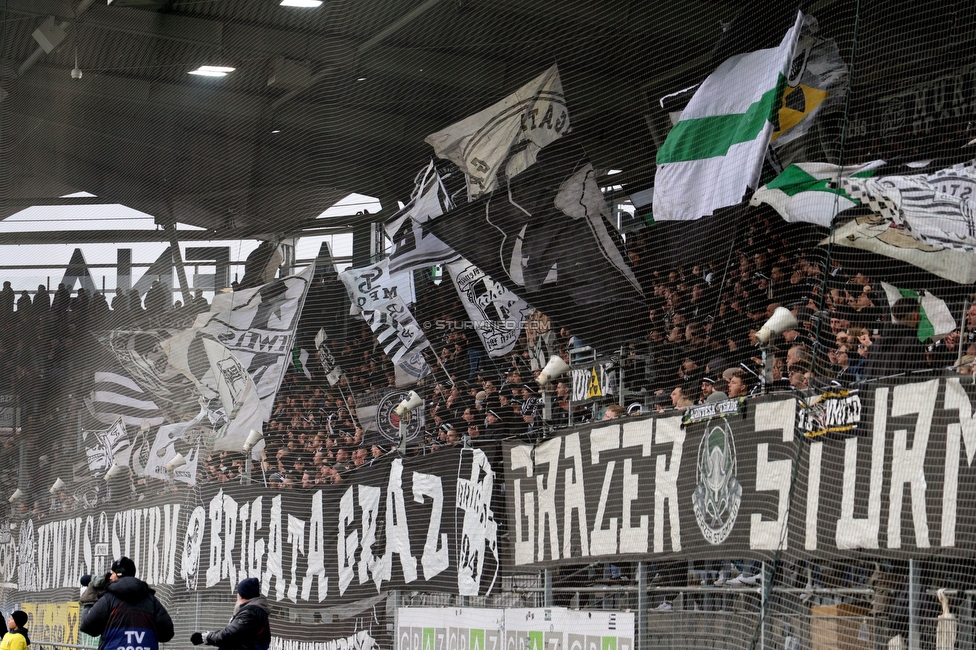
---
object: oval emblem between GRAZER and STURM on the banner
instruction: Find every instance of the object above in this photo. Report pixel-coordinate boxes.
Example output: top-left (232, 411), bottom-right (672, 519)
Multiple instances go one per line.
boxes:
top-left (692, 419), bottom-right (742, 544)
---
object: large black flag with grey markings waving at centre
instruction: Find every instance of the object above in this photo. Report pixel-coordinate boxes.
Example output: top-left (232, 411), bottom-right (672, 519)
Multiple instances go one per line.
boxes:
top-left (424, 136), bottom-right (643, 353)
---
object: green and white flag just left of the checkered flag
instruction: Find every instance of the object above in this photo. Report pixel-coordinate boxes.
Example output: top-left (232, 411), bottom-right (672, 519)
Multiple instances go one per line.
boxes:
top-left (749, 160), bottom-right (885, 228)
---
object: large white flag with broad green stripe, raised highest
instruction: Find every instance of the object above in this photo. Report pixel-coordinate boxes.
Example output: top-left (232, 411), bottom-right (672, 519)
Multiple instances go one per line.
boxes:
top-left (654, 12), bottom-right (803, 220)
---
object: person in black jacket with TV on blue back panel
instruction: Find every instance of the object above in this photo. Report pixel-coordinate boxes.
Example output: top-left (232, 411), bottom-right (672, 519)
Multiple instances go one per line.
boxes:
top-left (78, 557), bottom-right (173, 650)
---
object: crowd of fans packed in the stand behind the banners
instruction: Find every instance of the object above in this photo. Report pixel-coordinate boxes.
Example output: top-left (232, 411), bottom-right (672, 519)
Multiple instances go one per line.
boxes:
top-left (0, 210), bottom-right (976, 498)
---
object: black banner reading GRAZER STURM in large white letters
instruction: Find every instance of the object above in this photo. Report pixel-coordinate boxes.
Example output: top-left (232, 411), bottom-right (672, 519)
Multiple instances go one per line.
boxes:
top-left (505, 375), bottom-right (976, 568)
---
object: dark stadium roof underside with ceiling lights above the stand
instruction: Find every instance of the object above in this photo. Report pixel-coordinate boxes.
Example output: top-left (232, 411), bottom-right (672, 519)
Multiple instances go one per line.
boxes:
top-left (0, 0), bottom-right (968, 239)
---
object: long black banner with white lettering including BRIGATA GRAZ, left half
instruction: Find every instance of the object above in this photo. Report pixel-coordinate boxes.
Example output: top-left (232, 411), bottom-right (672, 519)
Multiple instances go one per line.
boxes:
top-left (0, 449), bottom-right (500, 607)
